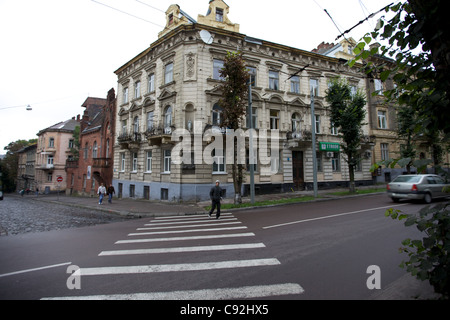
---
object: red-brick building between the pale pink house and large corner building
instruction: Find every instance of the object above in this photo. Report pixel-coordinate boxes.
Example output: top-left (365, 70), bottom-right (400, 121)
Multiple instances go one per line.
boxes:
top-left (66, 89), bottom-right (116, 196)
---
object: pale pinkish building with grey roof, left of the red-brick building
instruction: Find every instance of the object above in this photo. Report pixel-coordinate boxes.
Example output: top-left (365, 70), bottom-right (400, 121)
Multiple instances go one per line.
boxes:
top-left (35, 117), bottom-right (79, 193)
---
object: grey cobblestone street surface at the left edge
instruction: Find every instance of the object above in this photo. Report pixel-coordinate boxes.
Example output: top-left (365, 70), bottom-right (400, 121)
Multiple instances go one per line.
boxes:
top-left (0, 195), bottom-right (134, 236)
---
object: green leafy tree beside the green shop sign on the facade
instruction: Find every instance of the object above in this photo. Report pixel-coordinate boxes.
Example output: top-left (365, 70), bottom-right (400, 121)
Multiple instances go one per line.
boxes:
top-left (326, 78), bottom-right (366, 193)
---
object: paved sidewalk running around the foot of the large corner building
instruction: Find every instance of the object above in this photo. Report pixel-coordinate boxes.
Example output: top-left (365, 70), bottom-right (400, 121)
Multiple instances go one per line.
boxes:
top-left (29, 186), bottom-right (384, 217)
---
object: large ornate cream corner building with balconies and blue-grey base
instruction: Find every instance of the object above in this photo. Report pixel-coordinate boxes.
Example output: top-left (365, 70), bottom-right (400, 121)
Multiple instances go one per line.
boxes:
top-left (113, 0), bottom-right (373, 201)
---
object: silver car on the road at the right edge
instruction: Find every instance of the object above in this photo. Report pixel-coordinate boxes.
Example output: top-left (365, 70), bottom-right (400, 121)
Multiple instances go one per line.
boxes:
top-left (386, 174), bottom-right (450, 203)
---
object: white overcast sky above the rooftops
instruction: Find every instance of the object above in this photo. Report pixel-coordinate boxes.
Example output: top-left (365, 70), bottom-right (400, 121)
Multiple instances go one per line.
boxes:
top-left (0, 0), bottom-right (398, 154)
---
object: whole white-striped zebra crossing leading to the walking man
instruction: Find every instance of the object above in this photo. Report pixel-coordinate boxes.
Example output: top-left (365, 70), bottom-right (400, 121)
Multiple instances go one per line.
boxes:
top-left (46, 213), bottom-right (303, 300)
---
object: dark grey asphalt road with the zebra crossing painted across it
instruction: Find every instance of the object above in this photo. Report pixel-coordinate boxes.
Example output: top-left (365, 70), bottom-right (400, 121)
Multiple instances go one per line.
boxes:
top-left (0, 194), bottom-right (438, 300)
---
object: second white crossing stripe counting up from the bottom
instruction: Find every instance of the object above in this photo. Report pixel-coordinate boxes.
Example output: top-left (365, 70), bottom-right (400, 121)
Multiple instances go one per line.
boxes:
top-left (72, 258), bottom-right (280, 276)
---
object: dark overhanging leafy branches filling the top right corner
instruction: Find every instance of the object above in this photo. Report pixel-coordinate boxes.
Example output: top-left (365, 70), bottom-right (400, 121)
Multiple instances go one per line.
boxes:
top-left (349, 0), bottom-right (450, 139)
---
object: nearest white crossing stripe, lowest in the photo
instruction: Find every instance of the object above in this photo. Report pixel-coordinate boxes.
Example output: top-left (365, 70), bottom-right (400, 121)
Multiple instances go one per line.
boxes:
top-left (42, 283), bottom-right (304, 300)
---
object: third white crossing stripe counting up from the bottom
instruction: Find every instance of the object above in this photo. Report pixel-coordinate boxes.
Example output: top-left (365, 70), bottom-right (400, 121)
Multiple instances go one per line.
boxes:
top-left (99, 243), bottom-right (266, 256)
